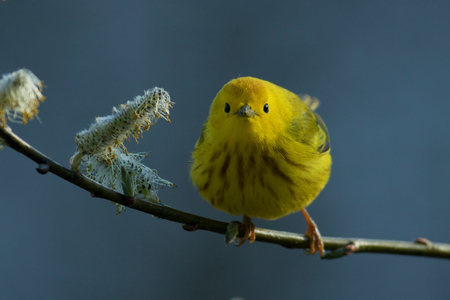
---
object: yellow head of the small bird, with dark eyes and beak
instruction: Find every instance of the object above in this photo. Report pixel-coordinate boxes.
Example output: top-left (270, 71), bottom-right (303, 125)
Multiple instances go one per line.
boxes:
top-left (209, 77), bottom-right (298, 141)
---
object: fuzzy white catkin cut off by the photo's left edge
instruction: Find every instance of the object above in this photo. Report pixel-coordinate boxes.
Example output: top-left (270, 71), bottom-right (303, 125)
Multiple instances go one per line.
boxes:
top-left (0, 69), bottom-right (45, 126)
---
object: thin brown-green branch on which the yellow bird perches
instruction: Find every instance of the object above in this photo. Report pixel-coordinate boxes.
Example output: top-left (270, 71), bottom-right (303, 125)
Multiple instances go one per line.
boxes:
top-left (0, 126), bottom-right (450, 259)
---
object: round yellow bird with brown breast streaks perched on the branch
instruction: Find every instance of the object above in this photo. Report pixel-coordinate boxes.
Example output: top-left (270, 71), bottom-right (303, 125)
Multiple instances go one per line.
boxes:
top-left (191, 77), bottom-right (331, 256)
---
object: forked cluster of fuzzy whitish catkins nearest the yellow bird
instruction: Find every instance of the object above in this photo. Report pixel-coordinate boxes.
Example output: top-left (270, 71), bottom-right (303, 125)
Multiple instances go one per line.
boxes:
top-left (71, 87), bottom-right (176, 213)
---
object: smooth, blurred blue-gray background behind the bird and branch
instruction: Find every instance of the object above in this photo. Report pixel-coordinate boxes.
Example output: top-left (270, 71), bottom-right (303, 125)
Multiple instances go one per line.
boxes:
top-left (0, 0), bottom-right (450, 300)
